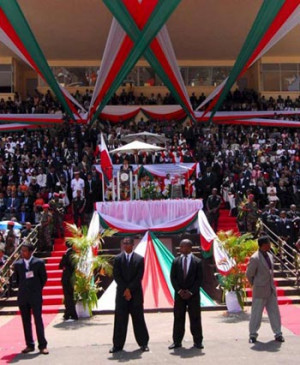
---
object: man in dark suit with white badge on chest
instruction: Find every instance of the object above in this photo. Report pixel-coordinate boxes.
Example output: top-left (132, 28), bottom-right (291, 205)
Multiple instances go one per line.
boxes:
top-left (13, 243), bottom-right (49, 355)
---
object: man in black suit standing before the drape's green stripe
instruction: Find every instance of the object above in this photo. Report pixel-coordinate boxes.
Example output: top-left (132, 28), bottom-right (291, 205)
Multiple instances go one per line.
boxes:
top-left (169, 239), bottom-right (203, 350)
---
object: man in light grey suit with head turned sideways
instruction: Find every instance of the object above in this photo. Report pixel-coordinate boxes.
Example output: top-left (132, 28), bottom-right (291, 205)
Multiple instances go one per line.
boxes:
top-left (246, 236), bottom-right (284, 343)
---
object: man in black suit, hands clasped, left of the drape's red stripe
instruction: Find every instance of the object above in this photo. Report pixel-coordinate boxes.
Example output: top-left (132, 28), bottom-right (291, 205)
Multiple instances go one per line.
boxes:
top-left (109, 237), bottom-right (149, 353)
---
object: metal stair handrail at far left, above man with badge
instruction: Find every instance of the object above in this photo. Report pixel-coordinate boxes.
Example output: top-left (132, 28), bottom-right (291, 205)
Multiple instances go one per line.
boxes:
top-left (0, 223), bottom-right (41, 298)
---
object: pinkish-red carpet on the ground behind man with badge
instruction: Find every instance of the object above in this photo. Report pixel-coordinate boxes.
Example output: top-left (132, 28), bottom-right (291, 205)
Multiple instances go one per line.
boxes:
top-left (0, 314), bottom-right (56, 364)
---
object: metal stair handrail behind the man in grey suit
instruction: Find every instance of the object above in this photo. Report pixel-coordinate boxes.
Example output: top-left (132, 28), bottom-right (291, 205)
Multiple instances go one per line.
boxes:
top-left (258, 220), bottom-right (300, 287)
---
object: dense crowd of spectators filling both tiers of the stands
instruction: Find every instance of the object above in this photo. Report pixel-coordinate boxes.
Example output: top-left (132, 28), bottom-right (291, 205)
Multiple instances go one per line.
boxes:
top-left (0, 90), bottom-right (300, 258)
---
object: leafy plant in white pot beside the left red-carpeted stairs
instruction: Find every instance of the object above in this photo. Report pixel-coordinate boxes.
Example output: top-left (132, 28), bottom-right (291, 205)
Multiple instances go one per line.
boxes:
top-left (66, 223), bottom-right (115, 317)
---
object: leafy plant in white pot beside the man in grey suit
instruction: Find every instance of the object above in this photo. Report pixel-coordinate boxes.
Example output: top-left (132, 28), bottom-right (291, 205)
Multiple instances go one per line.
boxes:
top-left (216, 231), bottom-right (258, 312)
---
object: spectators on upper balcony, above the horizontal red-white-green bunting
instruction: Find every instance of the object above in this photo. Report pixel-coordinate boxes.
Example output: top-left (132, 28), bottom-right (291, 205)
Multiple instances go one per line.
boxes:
top-left (0, 88), bottom-right (300, 114)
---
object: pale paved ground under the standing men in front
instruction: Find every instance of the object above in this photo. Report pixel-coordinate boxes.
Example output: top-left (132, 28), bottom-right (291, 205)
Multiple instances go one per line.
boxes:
top-left (5, 311), bottom-right (300, 365)
